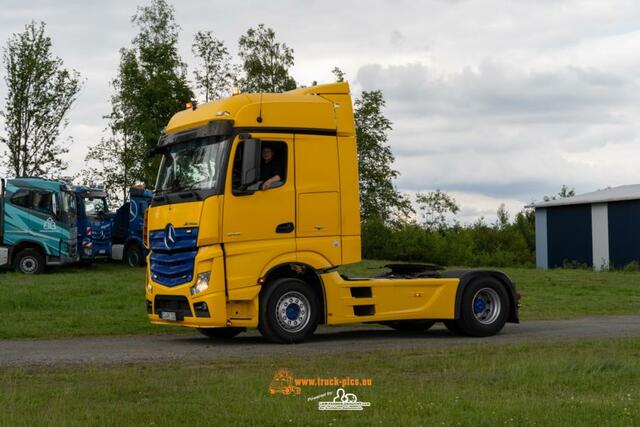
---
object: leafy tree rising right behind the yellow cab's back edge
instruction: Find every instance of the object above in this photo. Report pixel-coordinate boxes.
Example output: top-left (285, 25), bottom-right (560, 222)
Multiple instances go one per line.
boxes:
top-left (354, 90), bottom-right (413, 222)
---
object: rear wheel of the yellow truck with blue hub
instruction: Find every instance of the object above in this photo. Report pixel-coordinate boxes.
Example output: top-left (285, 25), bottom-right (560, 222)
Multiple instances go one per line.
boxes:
top-left (456, 277), bottom-right (510, 337)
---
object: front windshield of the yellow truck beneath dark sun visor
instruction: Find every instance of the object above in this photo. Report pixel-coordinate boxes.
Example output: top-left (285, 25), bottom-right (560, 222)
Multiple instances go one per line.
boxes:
top-left (156, 137), bottom-right (224, 193)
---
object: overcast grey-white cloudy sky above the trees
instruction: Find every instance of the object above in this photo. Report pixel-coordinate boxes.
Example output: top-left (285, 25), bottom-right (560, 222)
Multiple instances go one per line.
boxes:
top-left (0, 0), bottom-right (640, 221)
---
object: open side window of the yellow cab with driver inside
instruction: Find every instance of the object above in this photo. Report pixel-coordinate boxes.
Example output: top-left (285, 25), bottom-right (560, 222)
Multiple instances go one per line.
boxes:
top-left (232, 141), bottom-right (287, 190)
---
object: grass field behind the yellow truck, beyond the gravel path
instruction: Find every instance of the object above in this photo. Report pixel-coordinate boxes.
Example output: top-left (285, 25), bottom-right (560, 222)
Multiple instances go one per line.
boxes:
top-left (0, 260), bottom-right (640, 339)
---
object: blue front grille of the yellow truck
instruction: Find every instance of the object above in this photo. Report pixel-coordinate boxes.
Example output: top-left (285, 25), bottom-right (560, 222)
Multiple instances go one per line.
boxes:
top-left (149, 228), bottom-right (198, 287)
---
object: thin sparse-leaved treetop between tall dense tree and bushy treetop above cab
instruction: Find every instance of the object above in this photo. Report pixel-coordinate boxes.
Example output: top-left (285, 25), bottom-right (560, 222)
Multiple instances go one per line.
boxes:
top-left (191, 31), bottom-right (239, 102)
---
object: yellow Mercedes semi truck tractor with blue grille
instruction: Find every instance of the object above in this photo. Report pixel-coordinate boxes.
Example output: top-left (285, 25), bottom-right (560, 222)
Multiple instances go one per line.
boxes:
top-left (145, 83), bottom-right (519, 343)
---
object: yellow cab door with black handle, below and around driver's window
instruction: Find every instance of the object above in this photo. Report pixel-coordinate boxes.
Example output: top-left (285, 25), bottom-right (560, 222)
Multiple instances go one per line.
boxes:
top-left (222, 133), bottom-right (296, 291)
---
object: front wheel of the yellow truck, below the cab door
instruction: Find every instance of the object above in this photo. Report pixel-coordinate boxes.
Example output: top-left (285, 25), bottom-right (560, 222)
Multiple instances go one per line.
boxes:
top-left (258, 278), bottom-right (320, 344)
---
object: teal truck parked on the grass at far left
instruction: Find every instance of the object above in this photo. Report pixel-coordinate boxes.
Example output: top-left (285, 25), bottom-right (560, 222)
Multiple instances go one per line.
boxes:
top-left (0, 178), bottom-right (78, 274)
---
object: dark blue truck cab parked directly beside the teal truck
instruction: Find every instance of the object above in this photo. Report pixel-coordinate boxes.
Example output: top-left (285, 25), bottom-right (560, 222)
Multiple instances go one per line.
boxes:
top-left (74, 186), bottom-right (112, 261)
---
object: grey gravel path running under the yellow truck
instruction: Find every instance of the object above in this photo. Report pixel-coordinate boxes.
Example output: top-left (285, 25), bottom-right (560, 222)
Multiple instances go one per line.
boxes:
top-left (0, 316), bottom-right (640, 367)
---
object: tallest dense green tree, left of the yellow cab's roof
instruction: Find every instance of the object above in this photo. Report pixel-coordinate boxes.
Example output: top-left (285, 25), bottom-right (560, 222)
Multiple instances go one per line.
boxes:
top-left (80, 0), bottom-right (193, 192)
